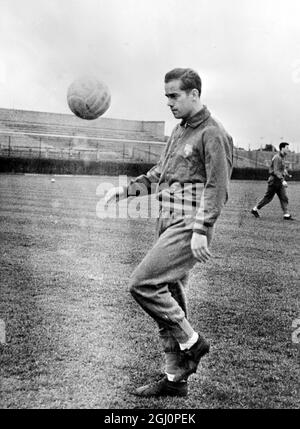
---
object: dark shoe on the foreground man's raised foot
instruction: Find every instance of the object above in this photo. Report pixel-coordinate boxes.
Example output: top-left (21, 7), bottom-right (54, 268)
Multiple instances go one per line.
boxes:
top-left (174, 335), bottom-right (210, 382)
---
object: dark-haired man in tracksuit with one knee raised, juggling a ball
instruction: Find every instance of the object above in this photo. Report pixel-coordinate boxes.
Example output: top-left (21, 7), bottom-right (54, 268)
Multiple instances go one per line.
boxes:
top-left (105, 68), bottom-right (233, 397)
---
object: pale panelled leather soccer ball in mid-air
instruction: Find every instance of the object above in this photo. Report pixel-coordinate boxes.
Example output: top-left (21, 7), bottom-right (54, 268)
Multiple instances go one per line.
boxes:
top-left (67, 76), bottom-right (111, 120)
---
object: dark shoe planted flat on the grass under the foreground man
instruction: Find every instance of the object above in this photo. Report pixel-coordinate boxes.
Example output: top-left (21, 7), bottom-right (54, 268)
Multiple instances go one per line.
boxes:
top-left (135, 376), bottom-right (188, 397)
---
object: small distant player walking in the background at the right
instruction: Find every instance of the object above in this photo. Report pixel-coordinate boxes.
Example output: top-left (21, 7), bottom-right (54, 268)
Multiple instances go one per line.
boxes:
top-left (251, 142), bottom-right (293, 220)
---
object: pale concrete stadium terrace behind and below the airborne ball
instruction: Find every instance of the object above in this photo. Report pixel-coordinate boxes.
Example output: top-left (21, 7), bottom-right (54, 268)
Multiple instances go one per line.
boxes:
top-left (0, 109), bottom-right (165, 162)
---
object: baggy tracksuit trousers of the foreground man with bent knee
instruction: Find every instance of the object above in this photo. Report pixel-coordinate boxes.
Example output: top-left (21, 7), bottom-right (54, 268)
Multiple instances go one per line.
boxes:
top-left (130, 213), bottom-right (196, 371)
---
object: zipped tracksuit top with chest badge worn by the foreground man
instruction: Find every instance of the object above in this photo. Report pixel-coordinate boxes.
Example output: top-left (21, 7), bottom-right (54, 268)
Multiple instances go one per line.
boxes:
top-left (127, 106), bottom-right (233, 235)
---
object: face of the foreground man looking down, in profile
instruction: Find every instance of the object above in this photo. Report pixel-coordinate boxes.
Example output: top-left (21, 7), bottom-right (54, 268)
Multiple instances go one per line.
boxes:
top-left (165, 79), bottom-right (195, 119)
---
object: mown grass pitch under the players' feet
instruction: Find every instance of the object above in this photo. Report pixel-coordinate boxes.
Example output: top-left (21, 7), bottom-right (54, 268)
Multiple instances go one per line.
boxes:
top-left (0, 175), bottom-right (300, 409)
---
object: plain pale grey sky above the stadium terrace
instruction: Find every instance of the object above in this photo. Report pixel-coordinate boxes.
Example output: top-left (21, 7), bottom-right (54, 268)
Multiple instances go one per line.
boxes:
top-left (0, 0), bottom-right (300, 152)
